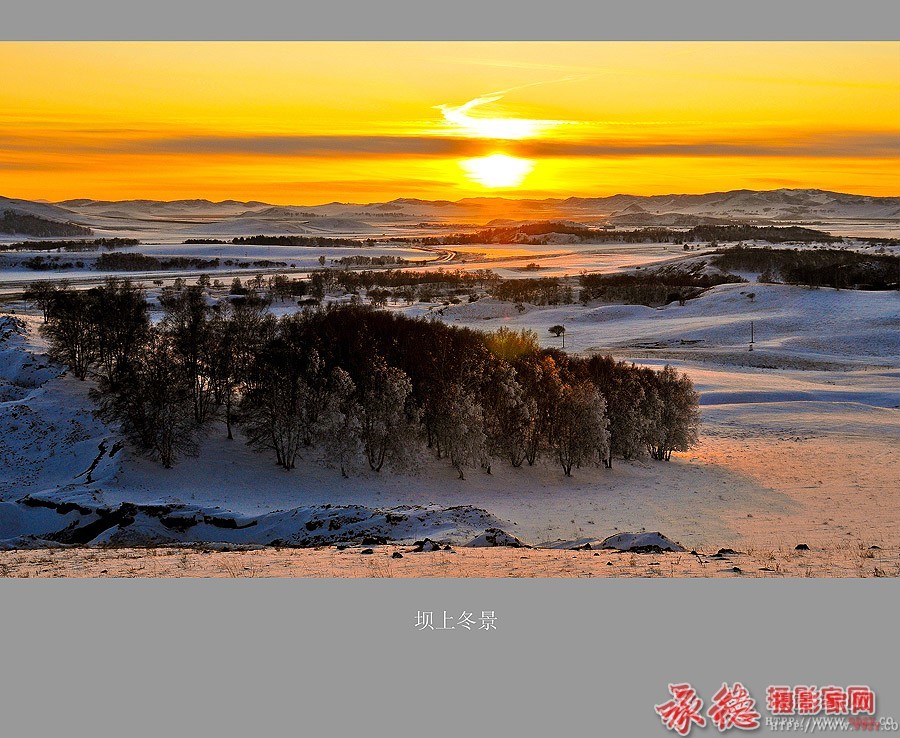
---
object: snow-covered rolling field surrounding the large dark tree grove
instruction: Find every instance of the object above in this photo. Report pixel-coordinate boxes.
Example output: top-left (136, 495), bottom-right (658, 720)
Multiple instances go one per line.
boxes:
top-left (0, 262), bottom-right (900, 576)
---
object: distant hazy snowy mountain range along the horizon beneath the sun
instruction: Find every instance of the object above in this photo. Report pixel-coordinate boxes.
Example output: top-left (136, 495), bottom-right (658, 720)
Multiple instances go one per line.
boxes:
top-left (0, 189), bottom-right (900, 235)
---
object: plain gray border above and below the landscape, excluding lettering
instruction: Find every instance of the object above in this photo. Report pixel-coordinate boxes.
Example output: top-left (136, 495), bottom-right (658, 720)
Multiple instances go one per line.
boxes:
top-left (0, 0), bottom-right (900, 738)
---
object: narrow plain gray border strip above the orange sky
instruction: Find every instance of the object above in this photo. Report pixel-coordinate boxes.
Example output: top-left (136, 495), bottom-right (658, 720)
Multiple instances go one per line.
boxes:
top-left (0, 0), bottom-right (900, 41)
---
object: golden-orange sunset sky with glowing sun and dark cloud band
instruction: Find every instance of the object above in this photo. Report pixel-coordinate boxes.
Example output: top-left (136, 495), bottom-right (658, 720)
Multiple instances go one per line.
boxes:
top-left (0, 42), bottom-right (900, 205)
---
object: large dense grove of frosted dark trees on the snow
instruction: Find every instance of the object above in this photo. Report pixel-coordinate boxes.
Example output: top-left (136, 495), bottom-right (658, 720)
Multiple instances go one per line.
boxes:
top-left (41, 280), bottom-right (699, 478)
